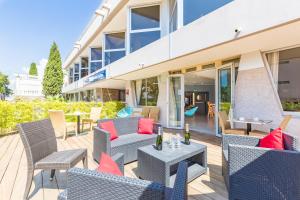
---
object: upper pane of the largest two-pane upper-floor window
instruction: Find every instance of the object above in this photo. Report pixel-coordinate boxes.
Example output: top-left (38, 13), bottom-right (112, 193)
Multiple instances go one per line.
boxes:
top-left (131, 5), bottom-right (160, 30)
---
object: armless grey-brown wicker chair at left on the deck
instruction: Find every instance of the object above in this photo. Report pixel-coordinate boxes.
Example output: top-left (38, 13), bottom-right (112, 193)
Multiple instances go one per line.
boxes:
top-left (17, 119), bottom-right (87, 199)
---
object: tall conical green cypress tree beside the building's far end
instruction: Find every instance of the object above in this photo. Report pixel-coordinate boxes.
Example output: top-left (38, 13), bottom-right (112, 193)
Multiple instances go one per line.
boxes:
top-left (43, 42), bottom-right (63, 97)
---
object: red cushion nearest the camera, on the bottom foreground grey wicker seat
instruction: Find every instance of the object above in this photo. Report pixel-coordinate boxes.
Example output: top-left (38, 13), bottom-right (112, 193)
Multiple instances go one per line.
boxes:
top-left (96, 153), bottom-right (123, 176)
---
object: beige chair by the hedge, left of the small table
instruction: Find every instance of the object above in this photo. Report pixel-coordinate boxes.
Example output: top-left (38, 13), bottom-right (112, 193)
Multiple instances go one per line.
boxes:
top-left (49, 110), bottom-right (77, 139)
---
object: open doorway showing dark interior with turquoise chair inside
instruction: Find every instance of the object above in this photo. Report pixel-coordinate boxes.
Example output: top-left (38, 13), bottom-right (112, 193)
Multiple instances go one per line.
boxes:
top-left (184, 68), bottom-right (216, 135)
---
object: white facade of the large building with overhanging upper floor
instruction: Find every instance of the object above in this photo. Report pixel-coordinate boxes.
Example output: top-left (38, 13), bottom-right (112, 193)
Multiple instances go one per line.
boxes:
top-left (63, 0), bottom-right (300, 134)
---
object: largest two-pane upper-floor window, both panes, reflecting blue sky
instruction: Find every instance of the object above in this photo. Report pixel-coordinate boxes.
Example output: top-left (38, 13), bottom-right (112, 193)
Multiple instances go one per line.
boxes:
top-left (130, 5), bottom-right (160, 52)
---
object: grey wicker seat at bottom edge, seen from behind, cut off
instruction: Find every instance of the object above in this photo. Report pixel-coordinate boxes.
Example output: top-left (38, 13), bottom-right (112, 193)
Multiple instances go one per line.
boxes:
top-left (58, 162), bottom-right (187, 200)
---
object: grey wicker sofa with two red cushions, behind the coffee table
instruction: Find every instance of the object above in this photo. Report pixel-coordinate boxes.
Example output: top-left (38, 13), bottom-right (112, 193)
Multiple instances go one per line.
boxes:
top-left (93, 117), bottom-right (160, 164)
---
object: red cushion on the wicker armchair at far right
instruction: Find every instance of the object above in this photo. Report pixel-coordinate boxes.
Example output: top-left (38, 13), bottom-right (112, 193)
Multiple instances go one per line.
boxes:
top-left (259, 128), bottom-right (284, 150)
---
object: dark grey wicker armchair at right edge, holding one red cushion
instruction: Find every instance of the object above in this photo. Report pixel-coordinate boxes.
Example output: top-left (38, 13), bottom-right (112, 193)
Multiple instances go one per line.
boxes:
top-left (222, 134), bottom-right (300, 200)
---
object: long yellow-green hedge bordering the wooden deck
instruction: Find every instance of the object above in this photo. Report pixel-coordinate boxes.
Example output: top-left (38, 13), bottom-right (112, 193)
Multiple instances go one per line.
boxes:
top-left (0, 101), bottom-right (124, 136)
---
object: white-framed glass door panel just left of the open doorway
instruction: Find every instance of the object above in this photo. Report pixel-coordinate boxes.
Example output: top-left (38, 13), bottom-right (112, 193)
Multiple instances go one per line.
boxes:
top-left (167, 75), bottom-right (184, 129)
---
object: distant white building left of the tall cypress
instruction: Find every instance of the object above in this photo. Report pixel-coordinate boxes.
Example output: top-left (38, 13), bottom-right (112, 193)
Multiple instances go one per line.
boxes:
top-left (13, 74), bottom-right (44, 99)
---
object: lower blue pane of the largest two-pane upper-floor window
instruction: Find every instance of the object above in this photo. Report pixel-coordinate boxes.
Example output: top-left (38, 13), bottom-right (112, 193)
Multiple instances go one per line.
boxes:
top-left (130, 31), bottom-right (160, 52)
